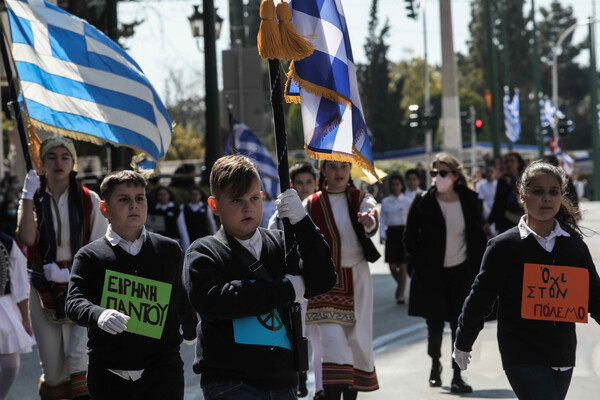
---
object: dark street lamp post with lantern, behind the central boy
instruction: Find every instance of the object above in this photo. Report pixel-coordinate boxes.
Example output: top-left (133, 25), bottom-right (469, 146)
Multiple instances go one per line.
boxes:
top-left (188, 0), bottom-right (223, 185)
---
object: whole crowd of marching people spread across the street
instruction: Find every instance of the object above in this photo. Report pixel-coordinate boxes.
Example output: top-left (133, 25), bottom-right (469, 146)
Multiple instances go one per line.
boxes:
top-left (0, 136), bottom-right (600, 400)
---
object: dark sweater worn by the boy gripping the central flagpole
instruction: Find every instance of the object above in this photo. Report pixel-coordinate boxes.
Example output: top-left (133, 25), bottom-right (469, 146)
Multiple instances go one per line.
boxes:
top-left (183, 217), bottom-right (335, 389)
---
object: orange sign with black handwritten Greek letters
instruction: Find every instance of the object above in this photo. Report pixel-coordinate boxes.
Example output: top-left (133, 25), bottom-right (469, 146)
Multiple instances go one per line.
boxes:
top-left (521, 263), bottom-right (590, 323)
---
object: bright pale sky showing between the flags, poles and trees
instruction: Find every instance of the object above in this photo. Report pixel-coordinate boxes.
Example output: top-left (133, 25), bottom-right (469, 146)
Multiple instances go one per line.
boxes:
top-left (117, 0), bottom-right (600, 99)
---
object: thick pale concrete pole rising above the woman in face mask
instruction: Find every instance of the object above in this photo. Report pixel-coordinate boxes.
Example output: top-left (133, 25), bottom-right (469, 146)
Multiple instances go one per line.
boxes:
top-left (440, 0), bottom-right (462, 160)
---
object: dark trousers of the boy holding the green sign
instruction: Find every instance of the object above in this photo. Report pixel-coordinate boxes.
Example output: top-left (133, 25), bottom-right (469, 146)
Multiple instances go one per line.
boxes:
top-left (87, 354), bottom-right (184, 400)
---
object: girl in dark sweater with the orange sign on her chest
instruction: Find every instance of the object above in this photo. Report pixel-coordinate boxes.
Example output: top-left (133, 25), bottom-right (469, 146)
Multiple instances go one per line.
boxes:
top-left (453, 161), bottom-right (600, 400)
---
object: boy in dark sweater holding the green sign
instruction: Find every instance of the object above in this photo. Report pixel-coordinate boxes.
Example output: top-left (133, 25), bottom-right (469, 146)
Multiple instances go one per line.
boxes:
top-left (66, 171), bottom-right (198, 400)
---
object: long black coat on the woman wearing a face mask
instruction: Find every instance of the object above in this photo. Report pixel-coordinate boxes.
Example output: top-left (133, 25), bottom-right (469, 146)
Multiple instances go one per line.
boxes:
top-left (404, 185), bottom-right (486, 318)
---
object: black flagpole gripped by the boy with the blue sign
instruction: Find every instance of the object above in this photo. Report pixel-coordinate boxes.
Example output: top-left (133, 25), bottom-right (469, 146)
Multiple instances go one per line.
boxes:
top-left (269, 59), bottom-right (308, 372)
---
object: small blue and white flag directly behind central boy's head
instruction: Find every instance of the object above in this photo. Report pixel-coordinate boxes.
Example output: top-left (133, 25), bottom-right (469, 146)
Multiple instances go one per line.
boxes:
top-left (225, 119), bottom-right (279, 198)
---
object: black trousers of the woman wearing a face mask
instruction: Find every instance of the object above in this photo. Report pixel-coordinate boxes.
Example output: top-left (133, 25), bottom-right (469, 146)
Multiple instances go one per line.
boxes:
top-left (425, 262), bottom-right (470, 374)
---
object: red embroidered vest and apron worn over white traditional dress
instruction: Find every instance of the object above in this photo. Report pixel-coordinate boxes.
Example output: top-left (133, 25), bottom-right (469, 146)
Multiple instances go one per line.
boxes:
top-left (306, 186), bottom-right (364, 326)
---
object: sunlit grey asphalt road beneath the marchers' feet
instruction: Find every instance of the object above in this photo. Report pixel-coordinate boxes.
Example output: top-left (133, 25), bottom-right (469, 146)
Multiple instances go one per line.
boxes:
top-left (7, 202), bottom-right (600, 400)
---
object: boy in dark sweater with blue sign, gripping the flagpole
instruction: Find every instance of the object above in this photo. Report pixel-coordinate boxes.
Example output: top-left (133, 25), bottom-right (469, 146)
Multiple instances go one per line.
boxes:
top-left (183, 155), bottom-right (335, 399)
